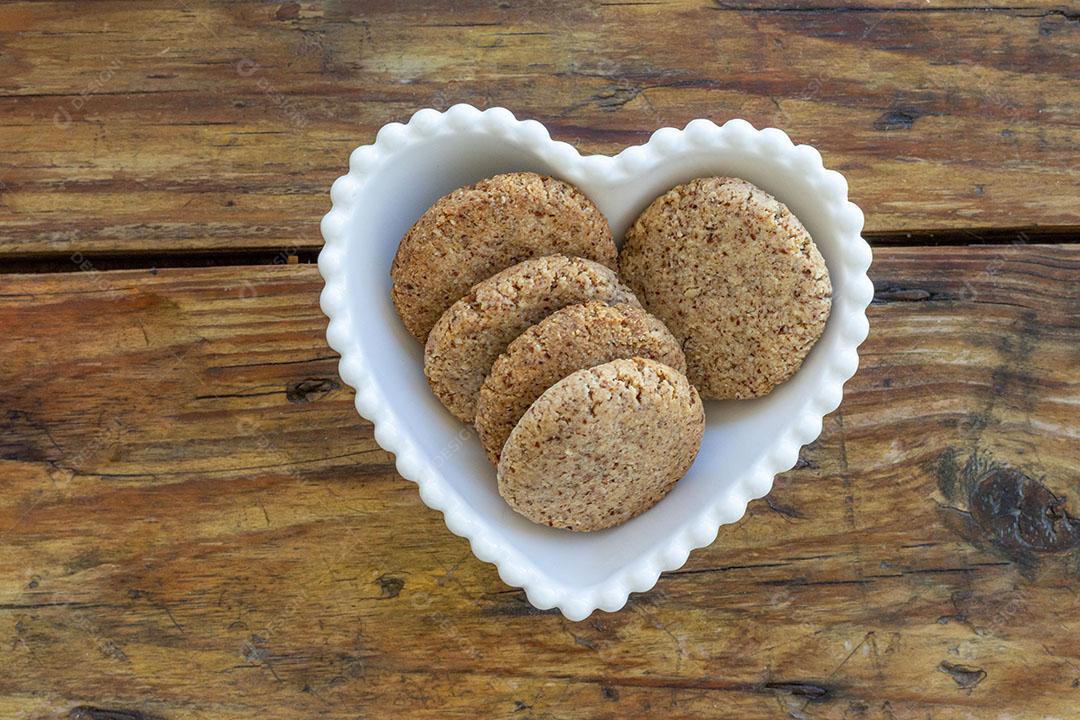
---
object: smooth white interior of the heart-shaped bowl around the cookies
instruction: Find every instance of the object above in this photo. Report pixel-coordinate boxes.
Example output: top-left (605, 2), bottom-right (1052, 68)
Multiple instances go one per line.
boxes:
top-left (347, 133), bottom-right (845, 588)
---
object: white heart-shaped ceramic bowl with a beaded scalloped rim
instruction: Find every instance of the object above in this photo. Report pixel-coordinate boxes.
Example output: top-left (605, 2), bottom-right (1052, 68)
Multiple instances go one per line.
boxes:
top-left (319, 105), bottom-right (874, 620)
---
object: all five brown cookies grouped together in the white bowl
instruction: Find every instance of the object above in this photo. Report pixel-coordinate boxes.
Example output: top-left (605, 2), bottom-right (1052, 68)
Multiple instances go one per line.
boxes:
top-left (391, 173), bottom-right (832, 531)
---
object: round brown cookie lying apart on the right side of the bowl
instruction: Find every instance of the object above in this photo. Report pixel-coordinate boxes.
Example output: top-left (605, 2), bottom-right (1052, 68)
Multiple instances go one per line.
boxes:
top-left (619, 177), bottom-right (833, 398)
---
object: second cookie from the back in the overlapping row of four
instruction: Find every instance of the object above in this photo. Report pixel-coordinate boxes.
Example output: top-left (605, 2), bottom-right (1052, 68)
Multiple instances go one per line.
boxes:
top-left (423, 255), bottom-right (639, 422)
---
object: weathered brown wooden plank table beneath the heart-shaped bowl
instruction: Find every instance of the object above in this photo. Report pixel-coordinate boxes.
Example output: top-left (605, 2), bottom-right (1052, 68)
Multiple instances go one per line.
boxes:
top-left (0, 0), bottom-right (1080, 720)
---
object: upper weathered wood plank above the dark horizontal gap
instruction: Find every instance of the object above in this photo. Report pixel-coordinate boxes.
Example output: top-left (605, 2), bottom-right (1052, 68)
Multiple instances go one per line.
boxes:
top-left (0, 0), bottom-right (1080, 255)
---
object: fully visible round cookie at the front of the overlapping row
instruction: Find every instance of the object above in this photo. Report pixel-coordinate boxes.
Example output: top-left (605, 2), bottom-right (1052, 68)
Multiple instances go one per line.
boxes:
top-left (498, 357), bottom-right (705, 531)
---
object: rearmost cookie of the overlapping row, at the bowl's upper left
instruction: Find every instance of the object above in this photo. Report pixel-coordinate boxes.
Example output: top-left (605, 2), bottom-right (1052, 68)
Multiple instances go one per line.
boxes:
top-left (390, 173), bottom-right (617, 342)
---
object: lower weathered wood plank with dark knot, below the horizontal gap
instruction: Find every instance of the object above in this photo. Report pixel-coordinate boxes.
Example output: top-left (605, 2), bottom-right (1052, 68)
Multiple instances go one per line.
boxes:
top-left (0, 245), bottom-right (1080, 720)
